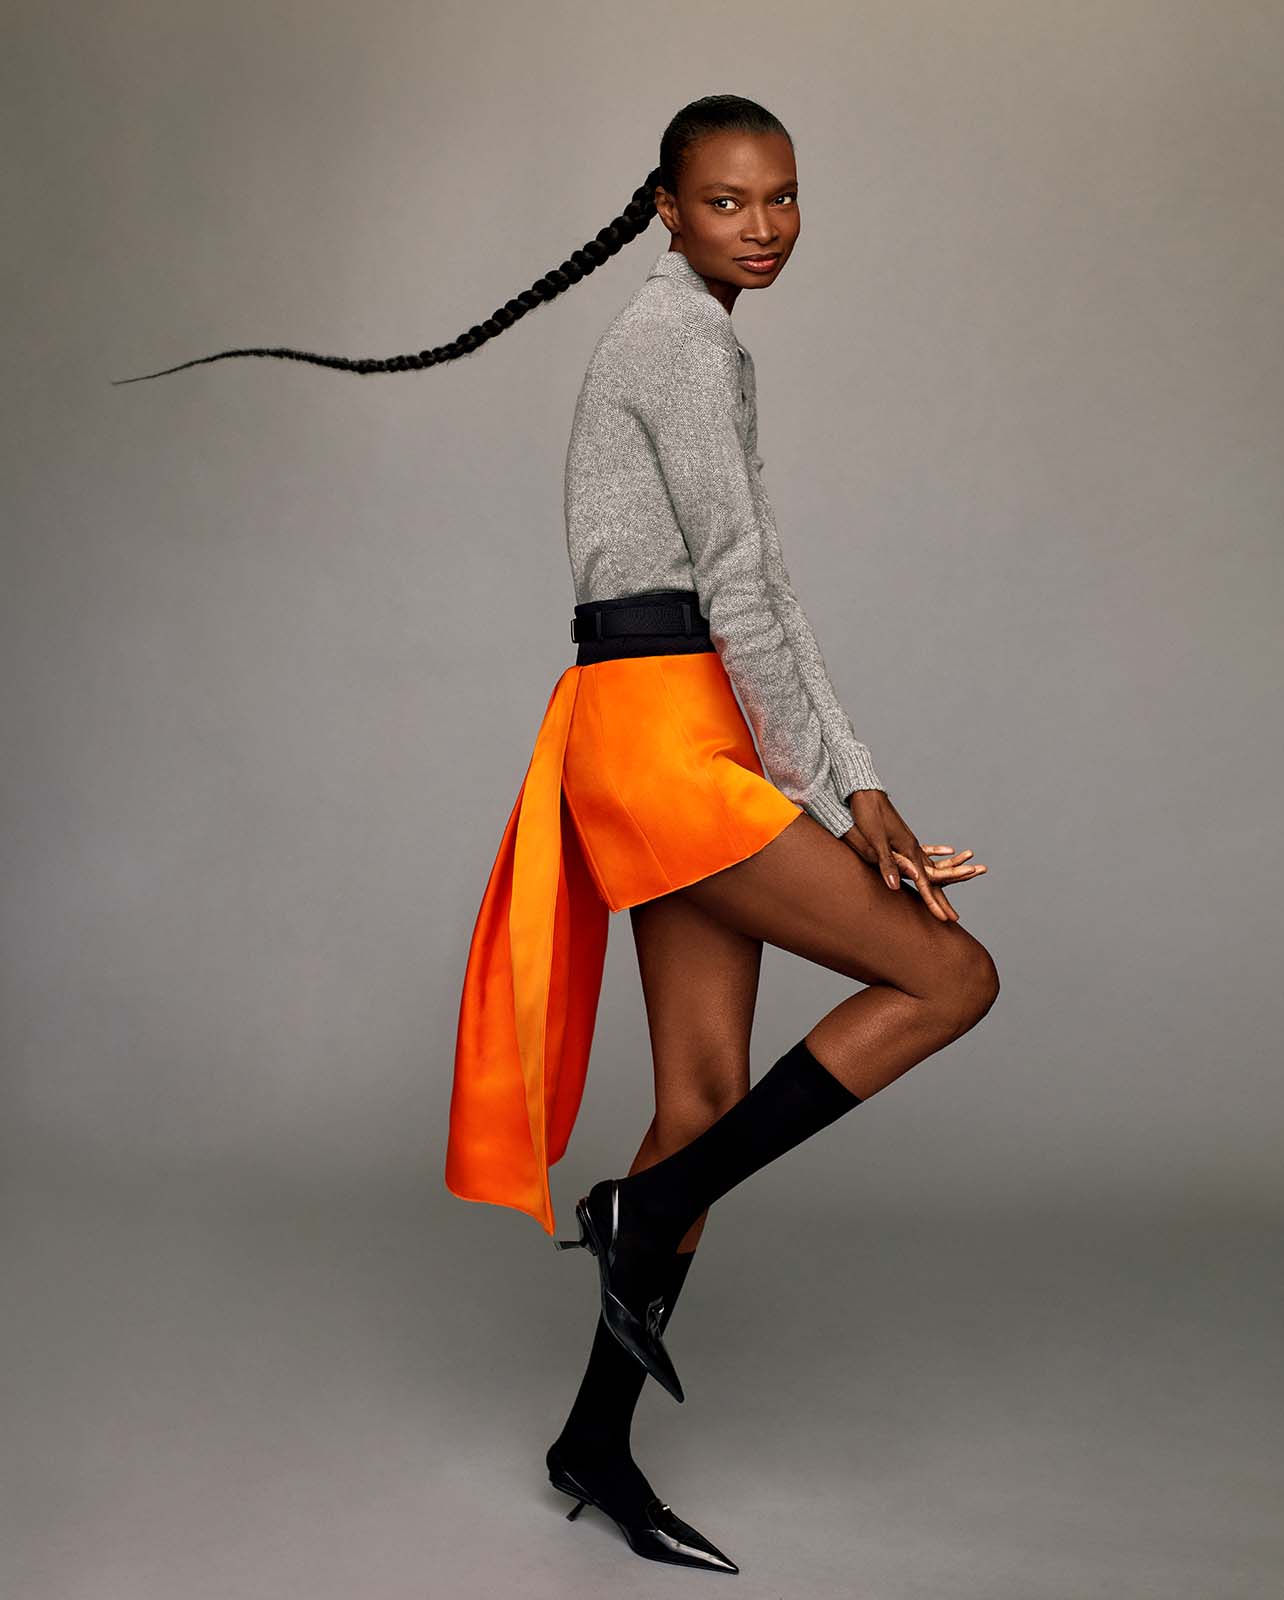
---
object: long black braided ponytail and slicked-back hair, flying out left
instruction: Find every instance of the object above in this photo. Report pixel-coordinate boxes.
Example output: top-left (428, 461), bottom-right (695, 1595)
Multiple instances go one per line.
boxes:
top-left (112, 94), bottom-right (789, 384)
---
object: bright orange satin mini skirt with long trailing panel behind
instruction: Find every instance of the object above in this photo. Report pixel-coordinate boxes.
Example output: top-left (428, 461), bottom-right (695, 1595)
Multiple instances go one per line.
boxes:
top-left (445, 650), bottom-right (802, 1234)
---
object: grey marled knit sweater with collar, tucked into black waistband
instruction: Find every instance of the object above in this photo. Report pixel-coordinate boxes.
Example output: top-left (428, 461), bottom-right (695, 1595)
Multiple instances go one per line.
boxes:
top-left (565, 250), bottom-right (885, 837)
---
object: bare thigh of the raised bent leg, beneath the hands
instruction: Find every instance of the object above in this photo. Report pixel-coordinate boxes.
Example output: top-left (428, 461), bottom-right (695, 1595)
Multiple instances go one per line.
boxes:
top-left (674, 811), bottom-right (993, 998)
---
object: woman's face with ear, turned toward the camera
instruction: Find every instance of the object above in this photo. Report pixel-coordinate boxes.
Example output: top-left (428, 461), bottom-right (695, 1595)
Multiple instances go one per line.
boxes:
top-left (655, 133), bottom-right (800, 310)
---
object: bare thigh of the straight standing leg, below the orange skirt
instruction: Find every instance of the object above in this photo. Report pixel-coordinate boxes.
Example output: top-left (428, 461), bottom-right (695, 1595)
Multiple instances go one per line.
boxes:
top-left (629, 894), bottom-right (762, 1136)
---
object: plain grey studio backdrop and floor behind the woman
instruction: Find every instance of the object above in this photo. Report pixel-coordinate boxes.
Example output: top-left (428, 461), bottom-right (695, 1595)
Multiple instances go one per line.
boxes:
top-left (0, 0), bottom-right (1284, 1600)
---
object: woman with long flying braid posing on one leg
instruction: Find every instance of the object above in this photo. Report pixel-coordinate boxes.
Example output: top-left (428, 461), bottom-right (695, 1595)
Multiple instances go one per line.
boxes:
top-left (115, 94), bottom-right (999, 1573)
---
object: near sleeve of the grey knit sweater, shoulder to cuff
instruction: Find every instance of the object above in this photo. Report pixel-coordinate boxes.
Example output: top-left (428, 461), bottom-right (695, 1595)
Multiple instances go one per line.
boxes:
top-left (629, 334), bottom-right (852, 837)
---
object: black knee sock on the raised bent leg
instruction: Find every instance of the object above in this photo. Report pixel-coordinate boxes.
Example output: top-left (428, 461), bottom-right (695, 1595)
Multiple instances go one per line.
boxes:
top-left (620, 1040), bottom-right (861, 1248)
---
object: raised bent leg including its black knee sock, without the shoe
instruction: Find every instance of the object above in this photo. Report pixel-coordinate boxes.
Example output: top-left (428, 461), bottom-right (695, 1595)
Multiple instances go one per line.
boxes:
top-left (576, 813), bottom-right (999, 1280)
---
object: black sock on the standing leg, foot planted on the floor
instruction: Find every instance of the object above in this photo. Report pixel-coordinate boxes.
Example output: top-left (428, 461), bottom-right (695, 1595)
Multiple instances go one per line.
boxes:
top-left (552, 1250), bottom-right (695, 1514)
